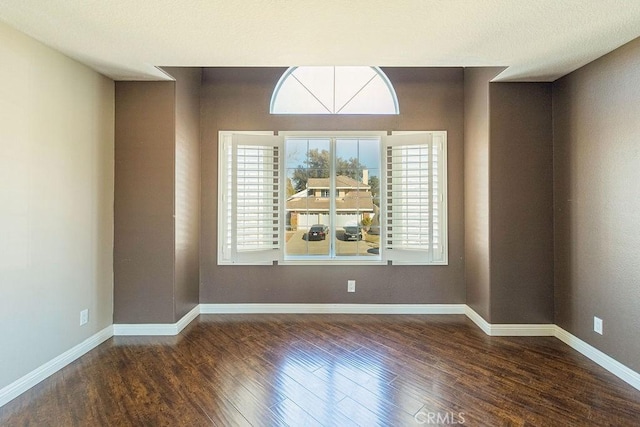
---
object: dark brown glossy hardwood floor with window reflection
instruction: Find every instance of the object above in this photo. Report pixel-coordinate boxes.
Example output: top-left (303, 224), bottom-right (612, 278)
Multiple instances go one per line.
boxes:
top-left (0, 315), bottom-right (640, 427)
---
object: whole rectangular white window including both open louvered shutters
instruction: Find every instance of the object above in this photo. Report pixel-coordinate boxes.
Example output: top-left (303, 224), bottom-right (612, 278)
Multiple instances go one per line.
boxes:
top-left (218, 131), bottom-right (448, 265)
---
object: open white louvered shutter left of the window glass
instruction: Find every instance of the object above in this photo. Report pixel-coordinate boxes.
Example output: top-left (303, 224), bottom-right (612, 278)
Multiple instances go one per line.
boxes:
top-left (218, 132), bottom-right (282, 264)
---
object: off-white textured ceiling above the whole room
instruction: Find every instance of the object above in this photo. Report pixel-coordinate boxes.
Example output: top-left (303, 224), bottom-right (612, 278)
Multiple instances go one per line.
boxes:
top-left (0, 0), bottom-right (640, 81)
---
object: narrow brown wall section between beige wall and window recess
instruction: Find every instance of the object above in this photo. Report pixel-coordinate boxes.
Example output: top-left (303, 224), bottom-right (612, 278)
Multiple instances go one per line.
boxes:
top-left (113, 82), bottom-right (175, 324)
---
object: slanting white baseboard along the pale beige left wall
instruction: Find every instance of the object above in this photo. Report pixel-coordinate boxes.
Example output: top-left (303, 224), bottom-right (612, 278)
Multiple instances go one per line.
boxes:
top-left (0, 326), bottom-right (113, 407)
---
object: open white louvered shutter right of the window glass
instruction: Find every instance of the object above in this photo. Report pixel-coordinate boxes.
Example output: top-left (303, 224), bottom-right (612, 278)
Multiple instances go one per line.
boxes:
top-left (383, 132), bottom-right (447, 264)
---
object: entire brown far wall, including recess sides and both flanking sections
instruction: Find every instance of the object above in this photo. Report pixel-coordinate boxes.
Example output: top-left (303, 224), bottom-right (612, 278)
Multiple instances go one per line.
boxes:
top-left (115, 68), bottom-right (553, 323)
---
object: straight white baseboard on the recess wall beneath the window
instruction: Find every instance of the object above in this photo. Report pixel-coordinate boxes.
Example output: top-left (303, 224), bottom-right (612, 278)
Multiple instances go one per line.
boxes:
top-left (200, 304), bottom-right (466, 314)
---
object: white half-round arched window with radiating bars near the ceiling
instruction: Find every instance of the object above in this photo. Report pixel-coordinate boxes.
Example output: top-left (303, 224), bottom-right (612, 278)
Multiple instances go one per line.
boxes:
top-left (270, 67), bottom-right (400, 114)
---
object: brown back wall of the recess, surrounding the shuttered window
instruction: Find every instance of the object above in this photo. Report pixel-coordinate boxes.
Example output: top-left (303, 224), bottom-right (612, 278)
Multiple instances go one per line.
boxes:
top-left (200, 68), bottom-right (465, 303)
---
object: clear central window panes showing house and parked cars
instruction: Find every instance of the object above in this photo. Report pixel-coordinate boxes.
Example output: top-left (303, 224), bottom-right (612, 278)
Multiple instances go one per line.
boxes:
top-left (284, 137), bottom-right (380, 259)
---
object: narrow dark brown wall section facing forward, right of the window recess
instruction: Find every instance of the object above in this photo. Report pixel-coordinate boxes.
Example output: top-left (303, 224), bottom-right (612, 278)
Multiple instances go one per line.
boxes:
top-left (489, 83), bottom-right (553, 323)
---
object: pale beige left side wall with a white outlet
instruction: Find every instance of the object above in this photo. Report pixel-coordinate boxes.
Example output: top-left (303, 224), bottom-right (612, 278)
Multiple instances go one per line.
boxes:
top-left (0, 23), bottom-right (114, 389)
